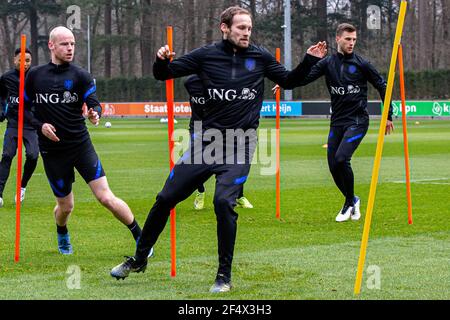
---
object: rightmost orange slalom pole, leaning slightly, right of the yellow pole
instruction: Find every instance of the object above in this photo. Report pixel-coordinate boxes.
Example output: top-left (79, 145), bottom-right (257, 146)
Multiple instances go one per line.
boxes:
top-left (398, 43), bottom-right (413, 224)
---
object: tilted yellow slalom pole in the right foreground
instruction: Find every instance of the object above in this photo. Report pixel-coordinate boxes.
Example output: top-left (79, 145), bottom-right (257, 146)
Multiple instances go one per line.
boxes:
top-left (354, 0), bottom-right (407, 295)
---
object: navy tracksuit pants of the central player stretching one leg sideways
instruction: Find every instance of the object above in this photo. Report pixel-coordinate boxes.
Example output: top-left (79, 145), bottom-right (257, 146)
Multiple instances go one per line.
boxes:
top-left (135, 136), bottom-right (256, 280)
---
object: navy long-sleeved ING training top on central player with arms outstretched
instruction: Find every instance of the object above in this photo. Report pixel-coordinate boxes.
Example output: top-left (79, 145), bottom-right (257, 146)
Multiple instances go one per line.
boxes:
top-left (153, 40), bottom-right (320, 130)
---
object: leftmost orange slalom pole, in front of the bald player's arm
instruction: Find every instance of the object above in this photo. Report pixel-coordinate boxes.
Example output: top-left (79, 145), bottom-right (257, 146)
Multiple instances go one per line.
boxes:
top-left (14, 35), bottom-right (27, 262)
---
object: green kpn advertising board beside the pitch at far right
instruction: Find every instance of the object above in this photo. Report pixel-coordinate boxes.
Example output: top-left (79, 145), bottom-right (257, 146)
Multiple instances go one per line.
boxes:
top-left (392, 101), bottom-right (450, 117)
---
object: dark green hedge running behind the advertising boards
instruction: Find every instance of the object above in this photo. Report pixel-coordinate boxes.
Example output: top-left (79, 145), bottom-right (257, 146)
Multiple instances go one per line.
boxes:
top-left (97, 70), bottom-right (450, 102)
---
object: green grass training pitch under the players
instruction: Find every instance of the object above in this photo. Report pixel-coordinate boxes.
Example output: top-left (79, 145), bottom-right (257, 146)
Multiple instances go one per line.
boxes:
top-left (0, 119), bottom-right (450, 299)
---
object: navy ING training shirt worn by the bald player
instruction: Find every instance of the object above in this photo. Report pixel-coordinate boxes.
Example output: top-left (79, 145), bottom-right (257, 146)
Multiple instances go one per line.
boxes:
top-left (25, 62), bottom-right (101, 150)
